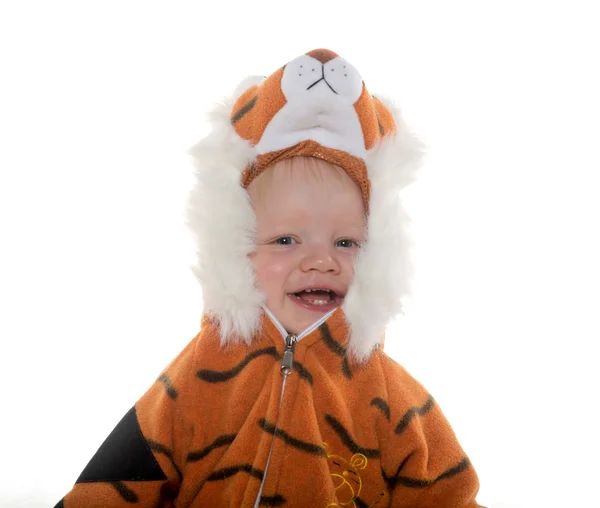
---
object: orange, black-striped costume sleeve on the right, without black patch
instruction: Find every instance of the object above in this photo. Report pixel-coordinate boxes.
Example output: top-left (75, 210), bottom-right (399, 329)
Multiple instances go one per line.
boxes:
top-left (382, 360), bottom-right (482, 508)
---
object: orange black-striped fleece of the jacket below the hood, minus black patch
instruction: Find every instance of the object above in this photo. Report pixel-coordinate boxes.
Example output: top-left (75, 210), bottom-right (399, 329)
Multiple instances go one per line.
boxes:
top-left (63, 309), bottom-right (479, 508)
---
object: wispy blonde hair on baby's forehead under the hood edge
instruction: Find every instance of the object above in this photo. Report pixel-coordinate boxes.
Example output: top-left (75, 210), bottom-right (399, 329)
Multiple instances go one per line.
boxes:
top-left (248, 156), bottom-right (362, 209)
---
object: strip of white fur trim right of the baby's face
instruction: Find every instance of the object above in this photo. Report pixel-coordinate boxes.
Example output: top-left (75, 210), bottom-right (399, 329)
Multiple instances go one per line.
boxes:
top-left (342, 97), bottom-right (423, 362)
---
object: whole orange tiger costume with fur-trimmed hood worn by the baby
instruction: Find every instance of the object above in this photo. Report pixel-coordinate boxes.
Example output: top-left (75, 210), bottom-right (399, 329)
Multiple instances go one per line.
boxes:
top-left (56, 50), bottom-right (479, 508)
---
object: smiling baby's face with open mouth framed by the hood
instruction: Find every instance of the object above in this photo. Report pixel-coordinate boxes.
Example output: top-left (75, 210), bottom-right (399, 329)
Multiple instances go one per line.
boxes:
top-left (248, 159), bottom-right (366, 334)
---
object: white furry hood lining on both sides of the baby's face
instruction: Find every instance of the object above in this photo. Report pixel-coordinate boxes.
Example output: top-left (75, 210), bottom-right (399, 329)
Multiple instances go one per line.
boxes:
top-left (187, 92), bottom-right (422, 362)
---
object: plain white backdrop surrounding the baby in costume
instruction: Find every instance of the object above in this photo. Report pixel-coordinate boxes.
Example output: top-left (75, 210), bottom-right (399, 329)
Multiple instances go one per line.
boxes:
top-left (0, 0), bottom-right (600, 508)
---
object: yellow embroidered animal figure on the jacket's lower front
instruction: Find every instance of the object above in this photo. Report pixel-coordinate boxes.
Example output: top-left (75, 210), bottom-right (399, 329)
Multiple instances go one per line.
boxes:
top-left (323, 443), bottom-right (368, 508)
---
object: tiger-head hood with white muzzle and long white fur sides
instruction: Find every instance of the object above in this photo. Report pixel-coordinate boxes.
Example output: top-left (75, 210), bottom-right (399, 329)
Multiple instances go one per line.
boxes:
top-left (187, 49), bottom-right (422, 361)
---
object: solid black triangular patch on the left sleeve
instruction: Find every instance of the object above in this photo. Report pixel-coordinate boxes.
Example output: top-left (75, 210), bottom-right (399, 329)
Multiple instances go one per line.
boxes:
top-left (77, 406), bottom-right (167, 484)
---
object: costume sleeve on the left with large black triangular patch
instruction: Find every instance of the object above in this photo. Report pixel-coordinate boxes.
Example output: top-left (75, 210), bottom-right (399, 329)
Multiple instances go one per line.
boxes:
top-left (55, 337), bottom-right (197, 508)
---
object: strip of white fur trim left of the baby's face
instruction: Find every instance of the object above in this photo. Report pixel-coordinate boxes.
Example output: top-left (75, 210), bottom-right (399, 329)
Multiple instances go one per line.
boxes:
top-left (187, 91), bottom-right (264, 344)
